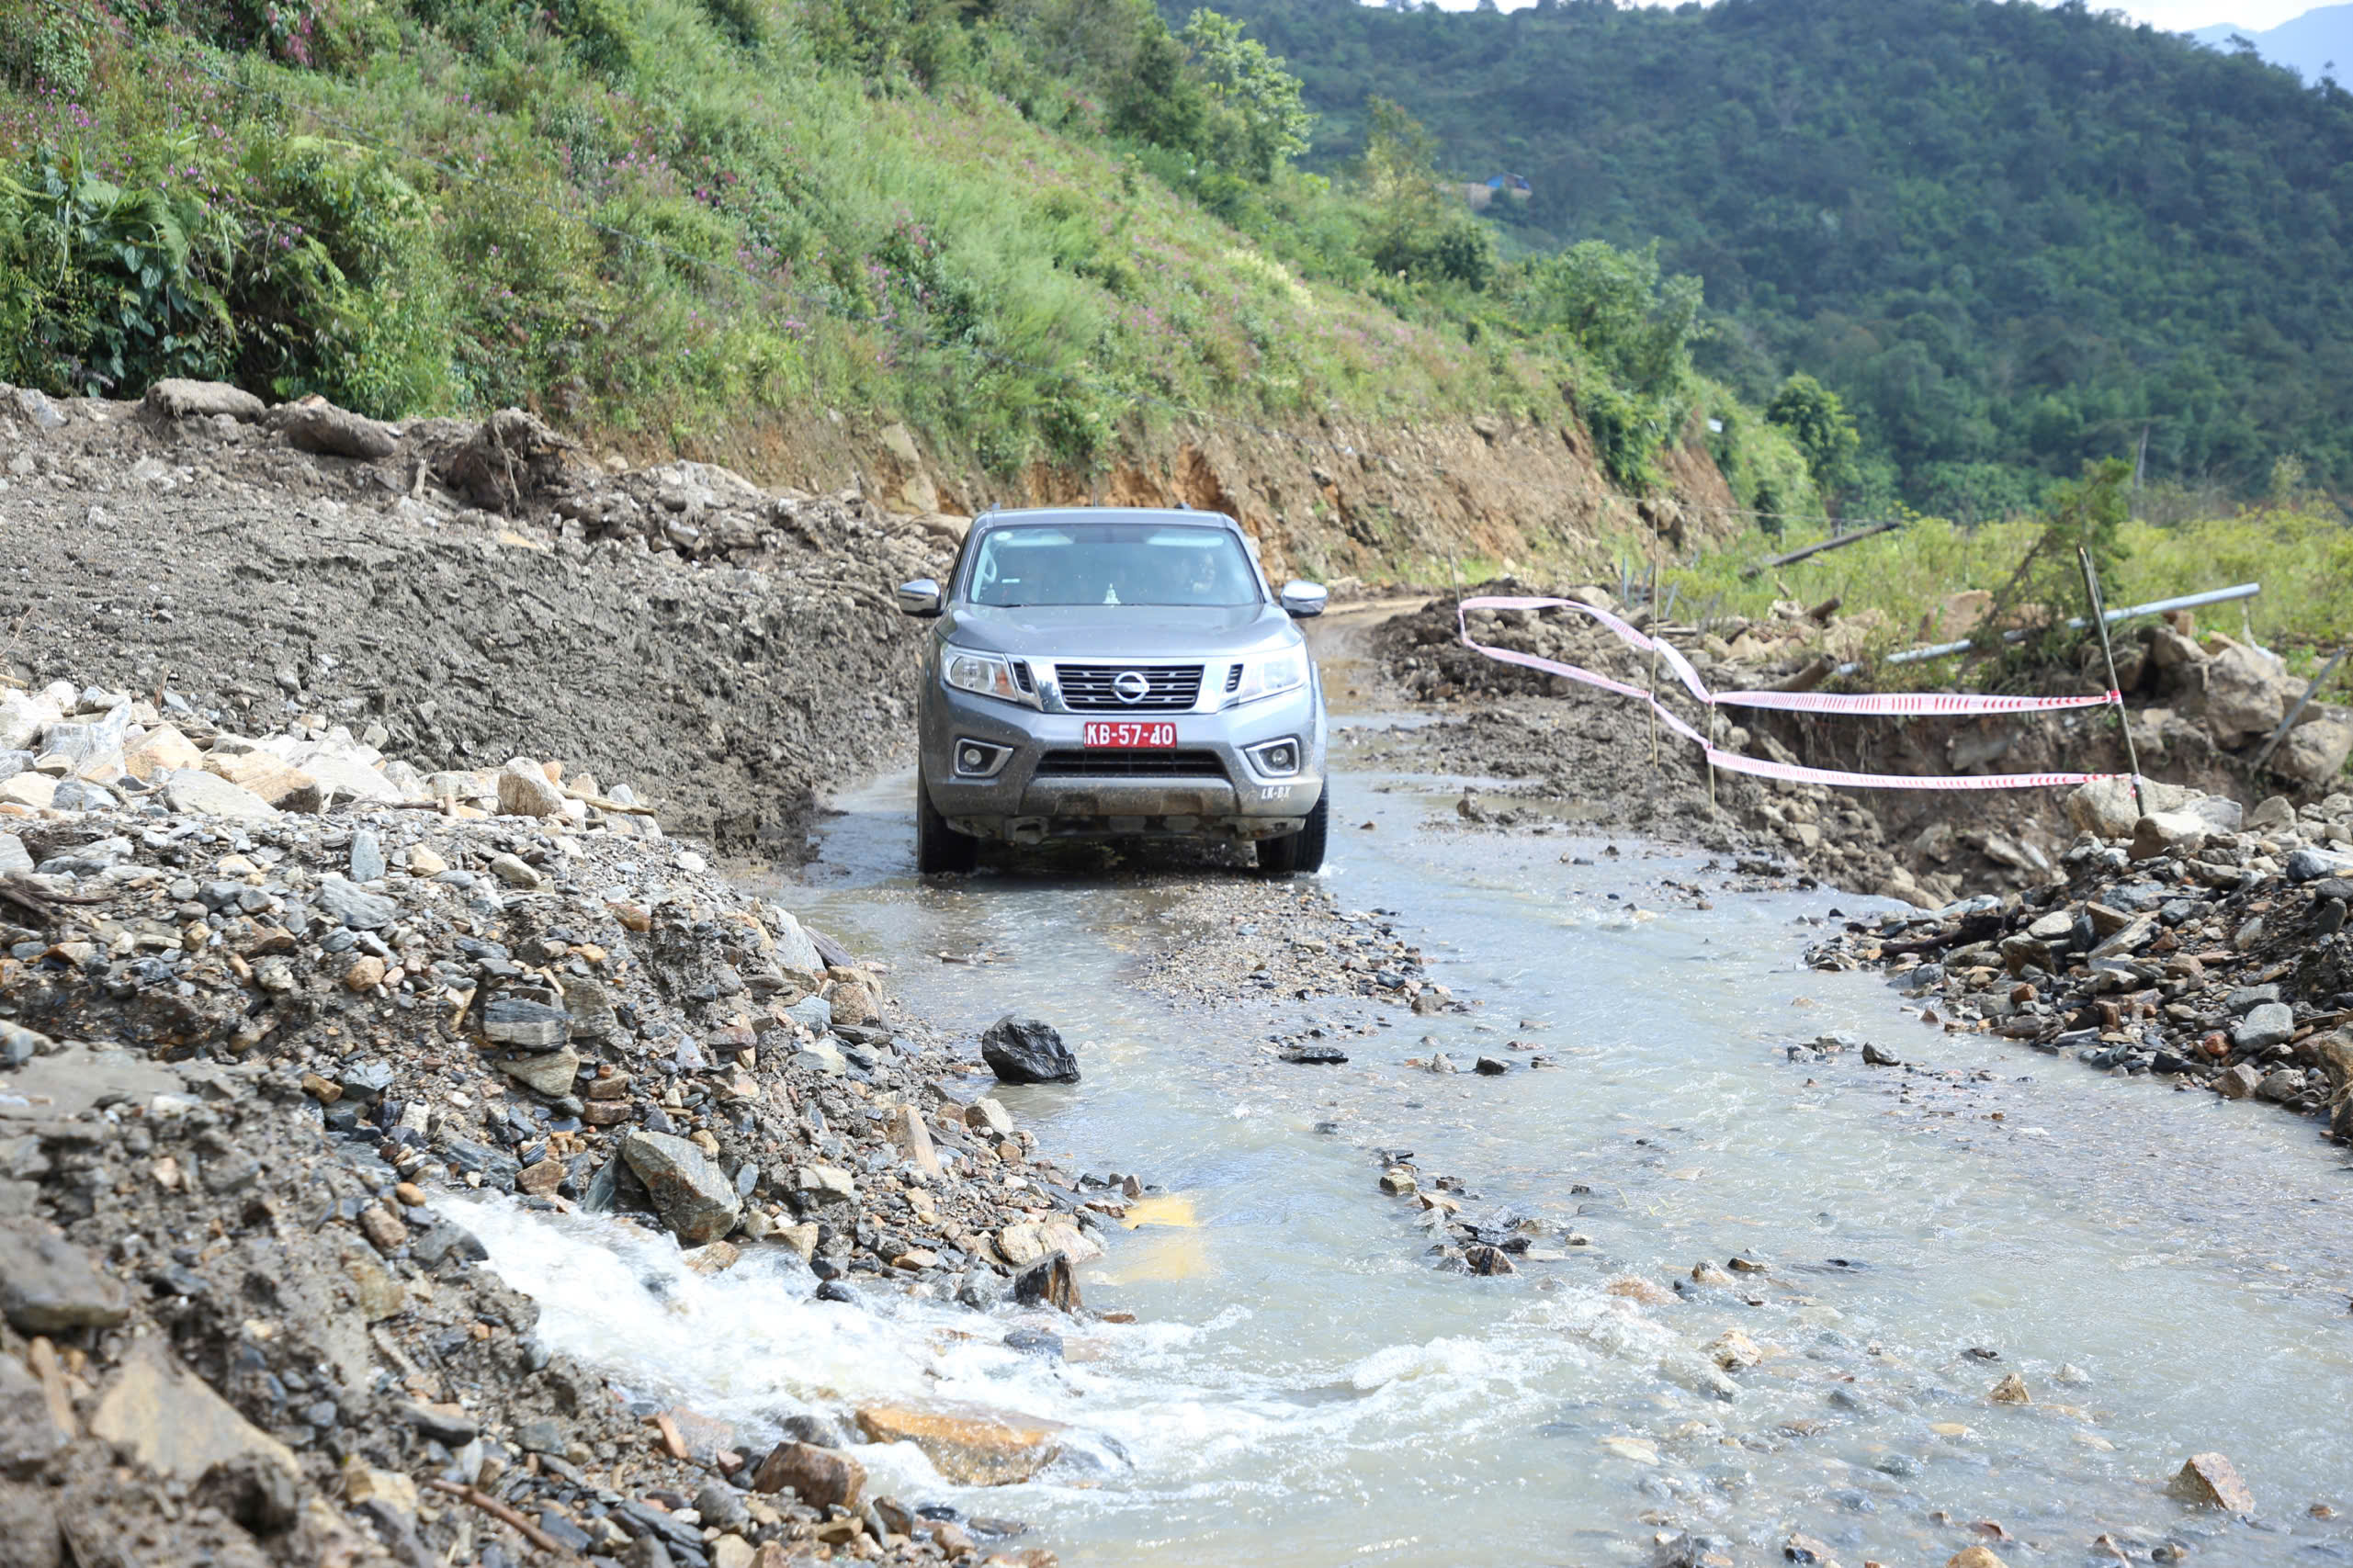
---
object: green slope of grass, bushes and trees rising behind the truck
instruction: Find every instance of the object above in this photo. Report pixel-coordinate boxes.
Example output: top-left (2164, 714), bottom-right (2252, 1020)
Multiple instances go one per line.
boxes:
top-left (0, 0), bottom-right (1815, 510)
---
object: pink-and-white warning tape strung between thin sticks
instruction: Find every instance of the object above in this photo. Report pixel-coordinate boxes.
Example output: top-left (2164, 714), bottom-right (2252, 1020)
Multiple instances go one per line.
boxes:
top-left (1456, 594), bottom-right (2125, 790)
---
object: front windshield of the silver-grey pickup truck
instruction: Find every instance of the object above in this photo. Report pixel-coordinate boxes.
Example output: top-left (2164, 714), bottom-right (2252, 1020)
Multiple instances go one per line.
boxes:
top-left (967, 522), bottom-right (1263, 606)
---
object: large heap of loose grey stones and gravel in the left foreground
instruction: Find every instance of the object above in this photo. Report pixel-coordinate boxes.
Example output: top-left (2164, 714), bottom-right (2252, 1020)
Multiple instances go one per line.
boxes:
top-left (0, 689), bottom-right (1141, 1568)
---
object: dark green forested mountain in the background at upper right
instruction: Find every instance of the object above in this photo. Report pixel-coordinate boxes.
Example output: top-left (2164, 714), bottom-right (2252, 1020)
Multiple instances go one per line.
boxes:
top-left (1179, 0), bottom-right (2353, 514)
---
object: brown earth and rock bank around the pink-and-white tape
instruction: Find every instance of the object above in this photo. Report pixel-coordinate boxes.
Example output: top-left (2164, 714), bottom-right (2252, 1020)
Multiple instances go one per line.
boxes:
top-left (1376, 583), bottom-right (2353, 908)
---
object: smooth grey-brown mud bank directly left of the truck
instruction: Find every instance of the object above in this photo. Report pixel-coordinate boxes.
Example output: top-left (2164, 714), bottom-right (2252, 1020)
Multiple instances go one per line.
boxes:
top-left (0, 383), bottom-right (956, 858)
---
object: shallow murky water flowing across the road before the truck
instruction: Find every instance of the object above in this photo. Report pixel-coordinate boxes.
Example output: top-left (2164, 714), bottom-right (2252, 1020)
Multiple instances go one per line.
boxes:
top-left (468, 620), bottom-right (2353, 1565)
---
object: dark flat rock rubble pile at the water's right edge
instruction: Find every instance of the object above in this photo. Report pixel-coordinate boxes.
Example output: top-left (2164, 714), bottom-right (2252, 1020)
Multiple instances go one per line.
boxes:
top-left (1807, 781), bottom-right (2353, 1140)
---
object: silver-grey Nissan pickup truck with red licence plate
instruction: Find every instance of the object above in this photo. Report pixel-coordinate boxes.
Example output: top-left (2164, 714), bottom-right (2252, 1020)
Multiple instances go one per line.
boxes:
top-left (899, 508), bottom-right (1329, 874)
